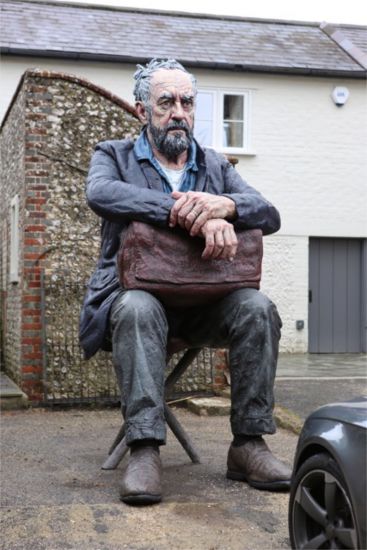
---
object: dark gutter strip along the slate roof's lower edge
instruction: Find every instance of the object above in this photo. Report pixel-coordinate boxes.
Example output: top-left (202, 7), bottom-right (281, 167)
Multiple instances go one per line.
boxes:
top-left (0, 47), bottom-right (367, 79)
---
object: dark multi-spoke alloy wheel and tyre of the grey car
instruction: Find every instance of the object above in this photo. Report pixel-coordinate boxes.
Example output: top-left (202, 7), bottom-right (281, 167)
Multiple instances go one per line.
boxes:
top-left (289, 453), bottom-right (358, 549)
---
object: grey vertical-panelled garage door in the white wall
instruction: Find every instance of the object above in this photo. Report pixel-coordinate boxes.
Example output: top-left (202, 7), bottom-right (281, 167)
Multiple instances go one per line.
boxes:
top-left (309, 238), bottom-right (365, 353)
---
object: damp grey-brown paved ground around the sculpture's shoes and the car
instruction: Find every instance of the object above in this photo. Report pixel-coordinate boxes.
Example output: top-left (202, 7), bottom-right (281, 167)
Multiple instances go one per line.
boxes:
top-left (1, 356), bottom-right (366, 550)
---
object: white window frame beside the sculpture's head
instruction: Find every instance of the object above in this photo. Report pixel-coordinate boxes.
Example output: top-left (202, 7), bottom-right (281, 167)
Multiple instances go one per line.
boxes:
top-left (198, 88), bottom-right (255, 155)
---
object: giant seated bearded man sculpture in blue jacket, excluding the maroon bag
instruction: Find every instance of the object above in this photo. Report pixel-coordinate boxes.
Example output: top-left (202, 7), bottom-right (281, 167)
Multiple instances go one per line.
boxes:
top-left (80, 59), bottom-right (291, 504)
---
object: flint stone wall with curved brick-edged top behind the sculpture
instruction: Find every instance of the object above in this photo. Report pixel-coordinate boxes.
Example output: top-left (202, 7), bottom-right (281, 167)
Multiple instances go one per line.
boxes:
top-left (2, 70), bottom-right (223, 401)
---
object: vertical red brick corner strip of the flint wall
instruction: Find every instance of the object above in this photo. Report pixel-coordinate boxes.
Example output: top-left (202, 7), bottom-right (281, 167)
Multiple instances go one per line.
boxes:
top-left (21, 78), bottom-right (52, 399)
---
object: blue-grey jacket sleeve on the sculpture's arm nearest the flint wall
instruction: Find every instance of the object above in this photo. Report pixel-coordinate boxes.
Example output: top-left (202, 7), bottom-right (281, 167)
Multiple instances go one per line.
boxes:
top-left (86, 142), bottom-right (174, 230)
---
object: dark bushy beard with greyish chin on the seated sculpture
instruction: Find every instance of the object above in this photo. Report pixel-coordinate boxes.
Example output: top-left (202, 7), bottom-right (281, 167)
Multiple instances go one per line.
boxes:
top-left (148, 120), bottom-right (193, 161)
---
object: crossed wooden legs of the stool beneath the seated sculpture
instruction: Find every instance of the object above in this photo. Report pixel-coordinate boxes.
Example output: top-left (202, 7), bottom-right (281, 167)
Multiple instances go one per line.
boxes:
top-left (102, 338), bottom-right (201, 470)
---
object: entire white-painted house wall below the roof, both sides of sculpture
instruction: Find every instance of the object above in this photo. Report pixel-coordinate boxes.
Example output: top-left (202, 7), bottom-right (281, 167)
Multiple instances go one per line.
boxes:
top-left (0, 56), bottom-right (367, 352)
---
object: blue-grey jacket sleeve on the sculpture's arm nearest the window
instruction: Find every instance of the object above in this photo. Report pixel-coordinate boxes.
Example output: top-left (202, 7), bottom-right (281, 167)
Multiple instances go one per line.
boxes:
top-left (222, 160), bottom-right (280, 235)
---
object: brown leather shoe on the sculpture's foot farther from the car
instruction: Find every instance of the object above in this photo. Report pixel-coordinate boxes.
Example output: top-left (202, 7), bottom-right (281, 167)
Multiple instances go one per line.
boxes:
top-left (120, 446), bottom-right (162, 505)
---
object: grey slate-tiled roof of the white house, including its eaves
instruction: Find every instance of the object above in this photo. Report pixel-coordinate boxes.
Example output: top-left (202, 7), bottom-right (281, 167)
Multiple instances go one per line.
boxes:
top-left (0, 0), bottom-right (367, 78)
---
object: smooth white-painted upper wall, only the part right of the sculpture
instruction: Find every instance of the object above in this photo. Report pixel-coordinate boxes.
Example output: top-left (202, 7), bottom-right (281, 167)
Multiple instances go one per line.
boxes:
top-left (198, 72), bottom-right (367, 237)
